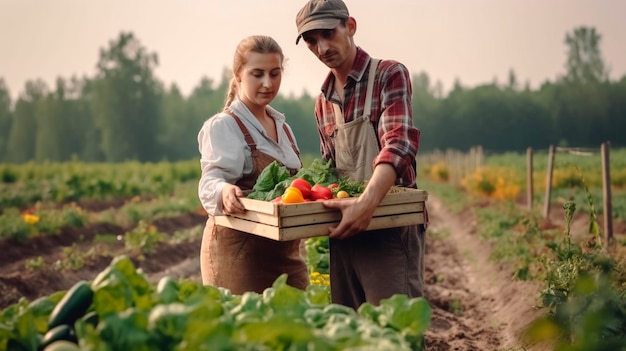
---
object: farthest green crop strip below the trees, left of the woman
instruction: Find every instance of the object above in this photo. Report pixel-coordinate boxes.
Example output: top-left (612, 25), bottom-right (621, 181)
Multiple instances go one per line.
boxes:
top-left (0, 161), bottom-right (200, 208)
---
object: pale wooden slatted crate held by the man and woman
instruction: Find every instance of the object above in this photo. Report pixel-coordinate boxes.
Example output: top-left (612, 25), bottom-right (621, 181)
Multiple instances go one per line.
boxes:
top-left (215, 187), bottom-right (428, 241)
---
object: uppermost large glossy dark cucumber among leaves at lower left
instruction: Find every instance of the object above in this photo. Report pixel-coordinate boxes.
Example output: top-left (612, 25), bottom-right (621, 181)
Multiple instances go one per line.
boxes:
top-left (48, 280), bottom-right (93, 330)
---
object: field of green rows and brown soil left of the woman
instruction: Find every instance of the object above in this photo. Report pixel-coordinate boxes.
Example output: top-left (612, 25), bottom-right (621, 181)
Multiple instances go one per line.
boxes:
top-left (0, 163), bottom-right (206, 308)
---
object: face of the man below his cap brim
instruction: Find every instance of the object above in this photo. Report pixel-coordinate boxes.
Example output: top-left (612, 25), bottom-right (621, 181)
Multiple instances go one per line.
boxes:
top-left (302, 24), bottom-right (352, 68)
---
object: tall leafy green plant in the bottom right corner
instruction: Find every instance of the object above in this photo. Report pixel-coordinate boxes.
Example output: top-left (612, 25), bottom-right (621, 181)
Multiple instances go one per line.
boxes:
top-left (528, 202), bottom-right (626, 351)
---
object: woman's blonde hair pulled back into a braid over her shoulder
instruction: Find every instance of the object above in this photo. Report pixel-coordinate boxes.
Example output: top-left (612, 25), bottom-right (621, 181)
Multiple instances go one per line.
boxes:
top-left (224, 35), bottom-right (285, 109)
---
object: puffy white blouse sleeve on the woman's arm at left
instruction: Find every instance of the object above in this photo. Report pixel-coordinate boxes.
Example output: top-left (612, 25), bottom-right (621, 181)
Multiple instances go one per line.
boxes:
top-left (198, 115), bottom-right (246, 216)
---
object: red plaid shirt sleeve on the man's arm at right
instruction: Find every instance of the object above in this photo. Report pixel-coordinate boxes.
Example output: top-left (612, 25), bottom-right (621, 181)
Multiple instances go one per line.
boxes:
top-left (373, 61), bottom-right (420, 185)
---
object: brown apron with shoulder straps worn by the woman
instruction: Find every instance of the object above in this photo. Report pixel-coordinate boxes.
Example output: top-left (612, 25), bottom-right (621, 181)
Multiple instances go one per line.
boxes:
top-left (200, 114), bottom-right (309, 295)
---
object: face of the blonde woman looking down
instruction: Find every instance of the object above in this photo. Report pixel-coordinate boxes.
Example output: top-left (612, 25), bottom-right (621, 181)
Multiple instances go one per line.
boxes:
top-left (237, 52), bottom-right (282, 107)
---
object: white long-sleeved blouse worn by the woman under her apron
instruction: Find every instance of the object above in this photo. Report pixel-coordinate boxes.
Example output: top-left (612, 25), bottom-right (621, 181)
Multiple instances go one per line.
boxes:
top-left (198, 99), bottom-right (300, 216)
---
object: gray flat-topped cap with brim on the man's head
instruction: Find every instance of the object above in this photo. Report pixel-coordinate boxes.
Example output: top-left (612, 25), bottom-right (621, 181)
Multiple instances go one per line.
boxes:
top-left (296, 0), bottom-right (350, 44)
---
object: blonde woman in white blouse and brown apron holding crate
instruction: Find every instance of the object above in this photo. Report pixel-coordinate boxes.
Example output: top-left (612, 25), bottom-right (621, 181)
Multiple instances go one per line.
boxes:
top-left (198, 35), bottom-right (309, 295)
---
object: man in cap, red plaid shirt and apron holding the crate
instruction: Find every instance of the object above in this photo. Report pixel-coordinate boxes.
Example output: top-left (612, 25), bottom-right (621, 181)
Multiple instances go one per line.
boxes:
top-left (296, 0), bottom-right (424, 309)
